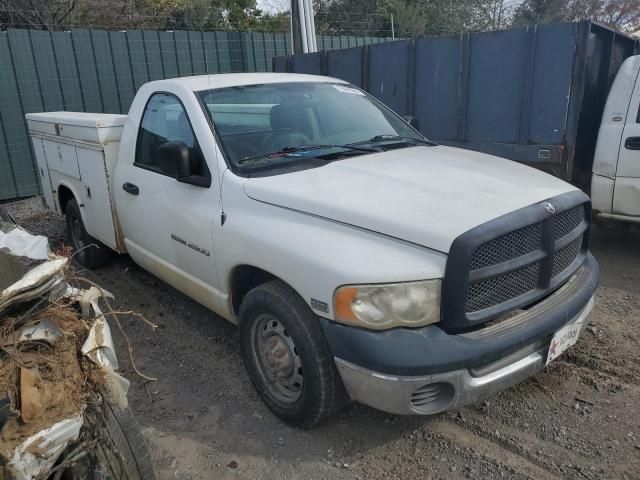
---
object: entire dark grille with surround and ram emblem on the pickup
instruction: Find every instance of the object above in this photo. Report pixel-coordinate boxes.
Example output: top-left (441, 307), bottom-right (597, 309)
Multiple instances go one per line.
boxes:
top-left (440, 190), bottom-right (591, 333)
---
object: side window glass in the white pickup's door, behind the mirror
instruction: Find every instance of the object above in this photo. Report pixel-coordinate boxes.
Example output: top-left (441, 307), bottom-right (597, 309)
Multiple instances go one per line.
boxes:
top-left (135, 93), bottom-right (210, 177)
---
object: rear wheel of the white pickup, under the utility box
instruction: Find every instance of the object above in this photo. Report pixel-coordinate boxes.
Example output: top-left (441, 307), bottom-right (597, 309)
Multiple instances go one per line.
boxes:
top-left (64, 199), bottom-right (112, 268)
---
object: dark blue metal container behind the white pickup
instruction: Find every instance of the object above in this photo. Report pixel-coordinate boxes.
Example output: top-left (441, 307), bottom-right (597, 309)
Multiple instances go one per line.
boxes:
top-left (273, 21), bottom-right (638, 188)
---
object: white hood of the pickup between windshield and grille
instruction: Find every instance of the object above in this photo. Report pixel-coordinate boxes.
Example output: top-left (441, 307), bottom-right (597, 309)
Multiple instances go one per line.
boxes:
top-left (244, 146), bottom-right (576, 253)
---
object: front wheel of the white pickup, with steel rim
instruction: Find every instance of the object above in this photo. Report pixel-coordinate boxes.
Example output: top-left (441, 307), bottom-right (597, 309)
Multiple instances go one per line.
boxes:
top-left (240, 280), bottom-right (348, 428)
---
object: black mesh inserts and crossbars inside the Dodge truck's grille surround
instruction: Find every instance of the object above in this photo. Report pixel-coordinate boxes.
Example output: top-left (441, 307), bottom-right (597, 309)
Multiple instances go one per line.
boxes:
top-left (465, 205), bottom-right (585, 313)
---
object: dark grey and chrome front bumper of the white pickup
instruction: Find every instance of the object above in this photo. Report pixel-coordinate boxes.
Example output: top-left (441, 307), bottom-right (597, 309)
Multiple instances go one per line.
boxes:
top-left (323, 255), bottom-right (598, 414)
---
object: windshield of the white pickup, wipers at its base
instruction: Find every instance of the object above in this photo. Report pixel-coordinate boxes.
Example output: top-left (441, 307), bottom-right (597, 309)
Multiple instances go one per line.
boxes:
top-left (198, 82), bottom-right (431, 171)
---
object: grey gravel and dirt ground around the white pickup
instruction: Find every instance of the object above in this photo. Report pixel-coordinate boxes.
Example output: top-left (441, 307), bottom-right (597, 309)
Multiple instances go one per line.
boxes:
top-left (7, 199), bottom-right (640, 480)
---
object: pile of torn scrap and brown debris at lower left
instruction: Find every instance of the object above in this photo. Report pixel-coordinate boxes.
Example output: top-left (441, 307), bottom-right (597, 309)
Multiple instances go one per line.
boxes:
top-left (0, 218), bottom-right (129, 480)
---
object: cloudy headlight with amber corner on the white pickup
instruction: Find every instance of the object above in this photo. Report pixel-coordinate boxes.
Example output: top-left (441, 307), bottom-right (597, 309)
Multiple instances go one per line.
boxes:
top-left (334, 280), bottom-right (441, 329)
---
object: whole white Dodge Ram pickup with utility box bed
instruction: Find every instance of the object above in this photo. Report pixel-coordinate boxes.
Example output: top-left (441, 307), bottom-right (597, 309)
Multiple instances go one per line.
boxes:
top-left (27, 74), bottom-right (599, 426)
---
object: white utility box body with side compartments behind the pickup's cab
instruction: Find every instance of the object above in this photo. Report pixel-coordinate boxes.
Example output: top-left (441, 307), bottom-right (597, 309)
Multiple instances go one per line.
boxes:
top-left (25, 112), bottom-right (127, 251)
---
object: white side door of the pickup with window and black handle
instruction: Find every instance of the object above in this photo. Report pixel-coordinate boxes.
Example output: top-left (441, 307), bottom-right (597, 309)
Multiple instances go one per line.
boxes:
top-left (114, 92), bottom-right (220, 309)
